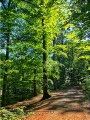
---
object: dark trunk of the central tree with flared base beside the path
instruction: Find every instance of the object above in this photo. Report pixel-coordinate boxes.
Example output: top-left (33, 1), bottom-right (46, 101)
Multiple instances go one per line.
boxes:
top-left (42, 19), bottom-right (51, 100)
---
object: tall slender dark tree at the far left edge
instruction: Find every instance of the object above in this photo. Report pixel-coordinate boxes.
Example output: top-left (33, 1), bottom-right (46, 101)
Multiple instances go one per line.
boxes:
top-left (0, 0), bottom-right (11, 106)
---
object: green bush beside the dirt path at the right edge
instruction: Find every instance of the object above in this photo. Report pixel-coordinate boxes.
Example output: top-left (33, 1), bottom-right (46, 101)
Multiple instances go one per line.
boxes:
top-left (82, 76), bottom-right (90, 99)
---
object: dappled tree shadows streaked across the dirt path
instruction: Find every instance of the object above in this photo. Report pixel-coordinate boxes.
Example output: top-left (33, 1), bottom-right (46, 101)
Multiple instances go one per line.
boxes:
top-left (5, 87), bottom-right (90, 114)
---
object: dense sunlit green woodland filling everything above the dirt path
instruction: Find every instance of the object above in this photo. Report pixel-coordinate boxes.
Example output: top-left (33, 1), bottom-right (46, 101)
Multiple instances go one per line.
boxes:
top-left (0, 0), bottom-right (90, 106)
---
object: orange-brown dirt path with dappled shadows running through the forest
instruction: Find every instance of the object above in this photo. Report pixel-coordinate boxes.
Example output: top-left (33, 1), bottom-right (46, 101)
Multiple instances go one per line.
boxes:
top-left (6, 86), bottom-right (90, 120)
